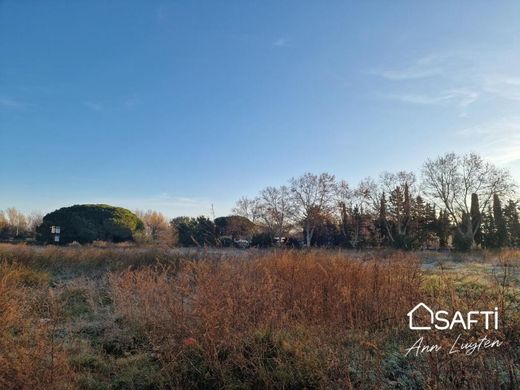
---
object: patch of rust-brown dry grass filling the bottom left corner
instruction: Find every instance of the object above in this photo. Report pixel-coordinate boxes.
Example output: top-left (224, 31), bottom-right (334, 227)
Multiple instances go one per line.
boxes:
top-left (0, 263), bottom-right (75, 389)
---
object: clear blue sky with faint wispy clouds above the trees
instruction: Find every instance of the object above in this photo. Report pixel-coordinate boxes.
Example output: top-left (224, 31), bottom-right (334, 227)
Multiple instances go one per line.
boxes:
top-left (0, 0), bottom-right (520, 217)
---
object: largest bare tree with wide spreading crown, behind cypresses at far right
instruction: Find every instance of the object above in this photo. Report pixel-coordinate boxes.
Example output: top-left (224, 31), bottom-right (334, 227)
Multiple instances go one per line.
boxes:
top-left (422, 153), bottom-right (513, 250)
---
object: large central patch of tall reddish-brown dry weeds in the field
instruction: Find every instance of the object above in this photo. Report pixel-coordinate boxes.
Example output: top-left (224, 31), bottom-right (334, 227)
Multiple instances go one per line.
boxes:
top-left (110, 251), bottom-right (421, 388)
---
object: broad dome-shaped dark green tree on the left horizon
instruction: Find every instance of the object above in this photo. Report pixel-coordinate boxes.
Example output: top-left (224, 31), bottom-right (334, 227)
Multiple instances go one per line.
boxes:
top-left (37, 204), bottom-right (144, 244)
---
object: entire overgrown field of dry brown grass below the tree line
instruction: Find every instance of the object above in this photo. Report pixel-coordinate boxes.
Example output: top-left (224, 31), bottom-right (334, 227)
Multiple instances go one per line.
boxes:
top-left (0, 244), bottom-right (520, 389)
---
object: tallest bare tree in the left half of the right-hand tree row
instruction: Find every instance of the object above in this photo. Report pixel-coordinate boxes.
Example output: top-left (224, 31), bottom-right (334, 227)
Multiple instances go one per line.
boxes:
top-left (290, 173), bottom-right (338, 247)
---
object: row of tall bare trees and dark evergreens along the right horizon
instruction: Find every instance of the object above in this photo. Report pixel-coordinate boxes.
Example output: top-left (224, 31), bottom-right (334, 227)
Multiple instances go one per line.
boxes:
top-left (234, 153), bottom-right (520, 249)
